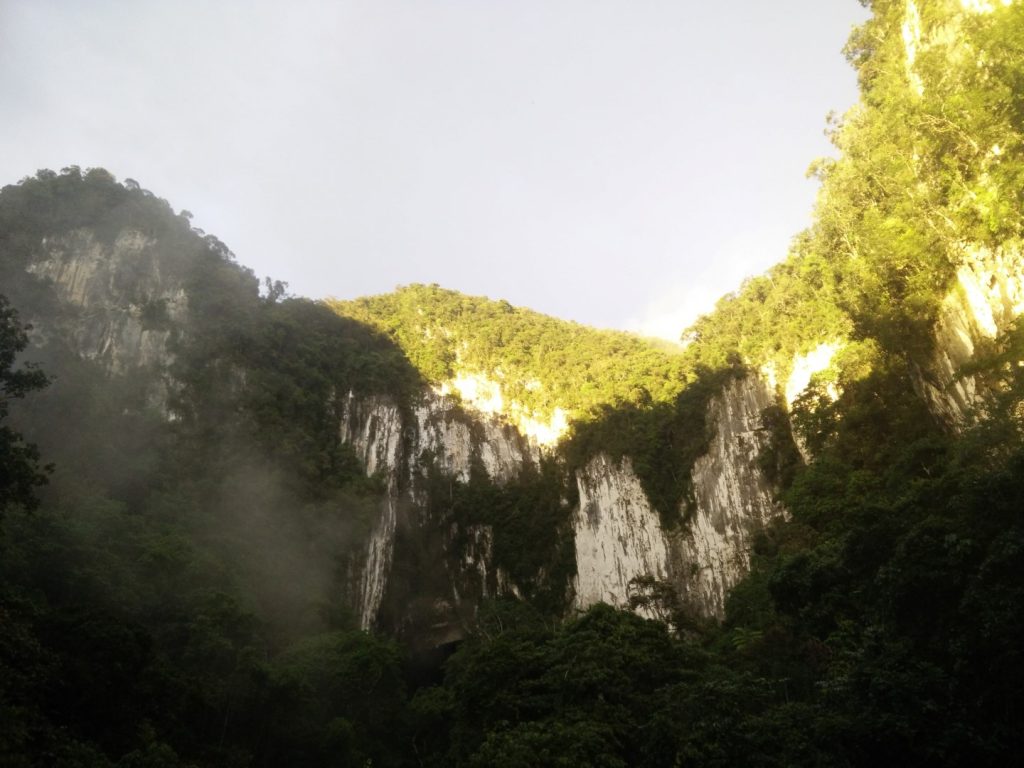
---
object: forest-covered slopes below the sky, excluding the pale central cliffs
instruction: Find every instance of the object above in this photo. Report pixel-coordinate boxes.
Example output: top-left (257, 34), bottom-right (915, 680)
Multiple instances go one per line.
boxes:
top-left (0, 0), bottom-right (1024, 768)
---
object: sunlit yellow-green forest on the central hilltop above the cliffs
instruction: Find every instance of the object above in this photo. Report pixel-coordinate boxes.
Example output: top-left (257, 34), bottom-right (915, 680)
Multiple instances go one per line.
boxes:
top-left (329, 285), bottom-right (686, 417)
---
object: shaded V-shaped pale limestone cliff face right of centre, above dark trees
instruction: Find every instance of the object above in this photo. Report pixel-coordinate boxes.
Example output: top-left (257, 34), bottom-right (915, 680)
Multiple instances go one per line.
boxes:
top-left (574, 375), bottom-right (783, 616)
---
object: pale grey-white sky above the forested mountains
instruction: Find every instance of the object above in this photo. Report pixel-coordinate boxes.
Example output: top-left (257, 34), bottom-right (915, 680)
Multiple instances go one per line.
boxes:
top-left (0, 0), bottom-right (866, 339)
